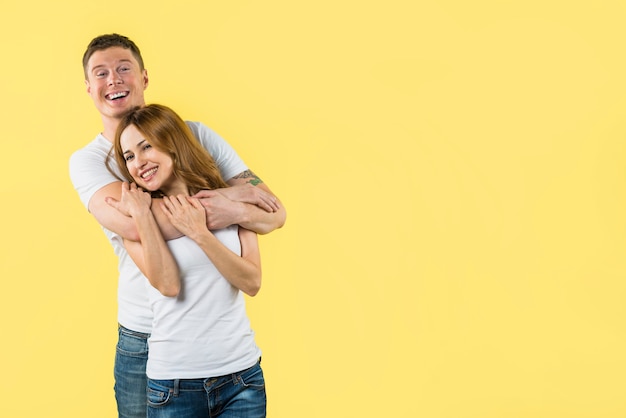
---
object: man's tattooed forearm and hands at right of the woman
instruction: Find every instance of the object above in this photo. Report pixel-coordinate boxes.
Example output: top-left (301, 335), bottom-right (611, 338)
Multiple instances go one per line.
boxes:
top-left (195, 170), bottom-right (287, 234)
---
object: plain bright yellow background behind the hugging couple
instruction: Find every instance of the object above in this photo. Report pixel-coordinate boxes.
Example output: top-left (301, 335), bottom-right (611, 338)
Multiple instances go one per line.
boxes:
top-left (0, 0), bottom-right (626, 418)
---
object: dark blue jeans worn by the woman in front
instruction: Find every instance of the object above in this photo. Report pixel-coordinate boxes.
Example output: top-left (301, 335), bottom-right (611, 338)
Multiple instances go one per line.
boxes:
top-left (148, 363), bottom-right (267, 418)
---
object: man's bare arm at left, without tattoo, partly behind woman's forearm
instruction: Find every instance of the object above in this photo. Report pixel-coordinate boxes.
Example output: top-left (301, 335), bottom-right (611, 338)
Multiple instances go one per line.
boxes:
top-left (89, 181), bottom-right (182, 241)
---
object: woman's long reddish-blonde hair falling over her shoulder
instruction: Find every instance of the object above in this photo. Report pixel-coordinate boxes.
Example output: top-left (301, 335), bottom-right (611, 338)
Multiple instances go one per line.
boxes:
top-left (113, 104), bottom-right (228, 195)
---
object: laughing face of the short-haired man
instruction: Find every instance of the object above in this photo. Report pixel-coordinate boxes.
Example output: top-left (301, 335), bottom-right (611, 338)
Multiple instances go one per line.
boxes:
top-left (85, 47), bottom-right (148, 118)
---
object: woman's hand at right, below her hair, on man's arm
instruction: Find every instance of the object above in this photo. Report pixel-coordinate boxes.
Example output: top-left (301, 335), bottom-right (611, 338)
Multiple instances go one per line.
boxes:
top-left (161, 194), bottom-right (208, 240)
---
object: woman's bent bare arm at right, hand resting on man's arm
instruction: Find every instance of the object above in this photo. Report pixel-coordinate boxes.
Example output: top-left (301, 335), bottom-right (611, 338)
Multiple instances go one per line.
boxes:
top-left (162, 195), bottom-right (261, 296)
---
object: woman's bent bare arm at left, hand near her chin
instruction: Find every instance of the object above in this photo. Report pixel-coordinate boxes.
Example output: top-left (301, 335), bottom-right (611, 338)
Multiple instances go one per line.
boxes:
top-left (120, 183), bottom-right (181, 297)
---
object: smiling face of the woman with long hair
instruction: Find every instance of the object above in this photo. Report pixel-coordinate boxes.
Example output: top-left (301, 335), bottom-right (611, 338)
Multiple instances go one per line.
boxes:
top-left (120, 125), bottom-right (174, 194)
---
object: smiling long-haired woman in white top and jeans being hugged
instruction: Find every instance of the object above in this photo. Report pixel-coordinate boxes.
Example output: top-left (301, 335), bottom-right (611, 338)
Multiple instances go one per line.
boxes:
top-left (114, 104), bottom-right (266, 418)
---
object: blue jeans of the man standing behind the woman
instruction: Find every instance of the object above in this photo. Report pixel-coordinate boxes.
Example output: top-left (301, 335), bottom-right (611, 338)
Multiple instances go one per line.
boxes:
top-left (113, 325), bottom-right (150, 418)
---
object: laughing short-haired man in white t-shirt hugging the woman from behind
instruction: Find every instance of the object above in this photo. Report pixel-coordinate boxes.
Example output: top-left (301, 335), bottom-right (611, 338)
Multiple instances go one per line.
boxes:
top-left (70, 34), bottom-right (286, 417)
